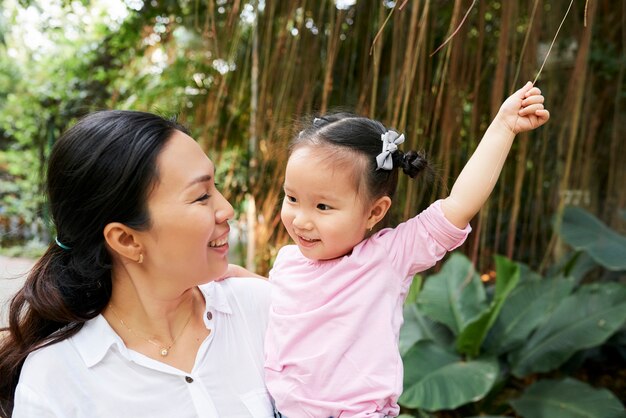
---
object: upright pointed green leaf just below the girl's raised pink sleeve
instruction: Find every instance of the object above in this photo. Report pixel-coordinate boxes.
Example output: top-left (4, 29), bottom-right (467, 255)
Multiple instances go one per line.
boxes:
top-left (417, 253), bottom-right (487, 335)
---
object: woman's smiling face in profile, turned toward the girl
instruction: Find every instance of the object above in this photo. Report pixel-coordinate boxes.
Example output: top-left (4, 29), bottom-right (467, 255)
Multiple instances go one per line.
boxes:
top-left (140, 131), bottom-right (233, 288)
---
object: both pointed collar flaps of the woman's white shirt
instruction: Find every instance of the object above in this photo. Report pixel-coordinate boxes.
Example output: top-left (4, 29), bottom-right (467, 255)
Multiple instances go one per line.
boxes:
top-left (71, 282), bottom-right (232, 367)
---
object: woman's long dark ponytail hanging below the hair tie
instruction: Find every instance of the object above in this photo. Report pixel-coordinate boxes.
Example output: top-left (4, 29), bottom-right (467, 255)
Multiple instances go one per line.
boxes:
top-left (0, 244), bottom-right (111, 418)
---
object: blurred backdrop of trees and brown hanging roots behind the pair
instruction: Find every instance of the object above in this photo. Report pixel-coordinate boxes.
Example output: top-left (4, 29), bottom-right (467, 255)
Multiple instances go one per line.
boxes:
top-left (0, 0), bottom-right (626, 273)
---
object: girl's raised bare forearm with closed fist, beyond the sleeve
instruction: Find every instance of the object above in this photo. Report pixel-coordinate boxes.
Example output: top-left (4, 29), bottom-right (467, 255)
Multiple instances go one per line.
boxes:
top-left (441, 81), bottom-right (550, 228)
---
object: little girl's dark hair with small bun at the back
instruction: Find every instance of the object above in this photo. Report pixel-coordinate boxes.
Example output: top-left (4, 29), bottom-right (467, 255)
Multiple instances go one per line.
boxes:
top-left (290, 113), bottom-right (429, 199)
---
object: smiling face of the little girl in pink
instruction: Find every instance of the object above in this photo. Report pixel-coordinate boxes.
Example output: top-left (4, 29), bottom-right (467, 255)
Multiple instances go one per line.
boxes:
top-left (281, 146), bottom-right (371, 260)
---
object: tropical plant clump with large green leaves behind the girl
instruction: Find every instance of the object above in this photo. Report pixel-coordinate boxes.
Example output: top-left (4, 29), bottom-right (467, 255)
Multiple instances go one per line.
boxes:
top-left (399, 207), bottom-right (626, 418)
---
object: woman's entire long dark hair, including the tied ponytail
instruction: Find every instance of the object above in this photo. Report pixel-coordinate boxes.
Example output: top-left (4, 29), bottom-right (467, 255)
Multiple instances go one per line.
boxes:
top-left (0, 110), bottom-right (186, 417)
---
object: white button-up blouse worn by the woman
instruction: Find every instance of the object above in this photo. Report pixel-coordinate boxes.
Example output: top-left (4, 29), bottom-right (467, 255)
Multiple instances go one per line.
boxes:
top-left (13, 278), bottom-right (274, 418)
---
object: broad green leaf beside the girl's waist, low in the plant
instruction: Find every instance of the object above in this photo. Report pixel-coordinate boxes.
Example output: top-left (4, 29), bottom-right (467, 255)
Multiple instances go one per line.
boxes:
top-left (399, 341), bottom-right (499, 411)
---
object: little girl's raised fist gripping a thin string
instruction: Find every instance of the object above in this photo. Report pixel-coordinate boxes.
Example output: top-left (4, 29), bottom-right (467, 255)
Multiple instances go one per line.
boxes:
top-left (496, 81), bottom-right (550, 134)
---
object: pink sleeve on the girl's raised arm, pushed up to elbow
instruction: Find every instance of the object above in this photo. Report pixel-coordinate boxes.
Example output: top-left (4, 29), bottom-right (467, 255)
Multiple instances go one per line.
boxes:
top-left (374, 200), bottom-right (472, 276)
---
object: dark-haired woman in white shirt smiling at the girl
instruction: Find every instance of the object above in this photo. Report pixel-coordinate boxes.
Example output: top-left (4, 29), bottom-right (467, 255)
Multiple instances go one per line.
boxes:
top-left (0, 111), bottom-right (274, 418)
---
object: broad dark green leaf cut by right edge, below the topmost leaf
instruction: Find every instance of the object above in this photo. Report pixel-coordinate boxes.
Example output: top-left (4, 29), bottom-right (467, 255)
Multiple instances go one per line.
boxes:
top-left (509, 283), bottom-right (626, 377)
